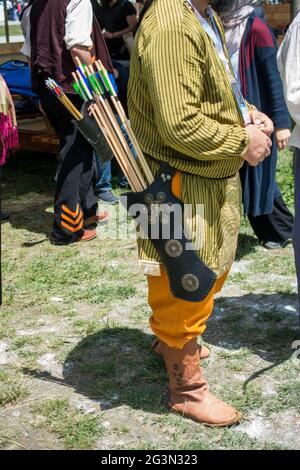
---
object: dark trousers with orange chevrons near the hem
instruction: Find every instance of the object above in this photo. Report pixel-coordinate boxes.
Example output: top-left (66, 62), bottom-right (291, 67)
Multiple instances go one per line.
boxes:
top-left (38, 83), bottom-right (97, 243)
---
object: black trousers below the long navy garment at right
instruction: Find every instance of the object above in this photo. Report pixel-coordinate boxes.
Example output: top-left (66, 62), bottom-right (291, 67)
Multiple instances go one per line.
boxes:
top-left (248, 196), bottom-right (294, 243)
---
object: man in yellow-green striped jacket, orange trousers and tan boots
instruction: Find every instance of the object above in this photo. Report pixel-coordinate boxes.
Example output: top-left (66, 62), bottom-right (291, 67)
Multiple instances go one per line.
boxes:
top-left (128, 0), bottom-right (273, 426)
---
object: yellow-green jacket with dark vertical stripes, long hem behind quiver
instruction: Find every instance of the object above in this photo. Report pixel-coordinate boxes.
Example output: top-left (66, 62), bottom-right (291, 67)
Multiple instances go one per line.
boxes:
top-left (128, 0), bottom-right (248, 276)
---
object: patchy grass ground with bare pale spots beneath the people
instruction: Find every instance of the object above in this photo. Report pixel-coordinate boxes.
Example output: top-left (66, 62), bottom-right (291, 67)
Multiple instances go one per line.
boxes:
top-left (0, 152), bottom-right (300, 449)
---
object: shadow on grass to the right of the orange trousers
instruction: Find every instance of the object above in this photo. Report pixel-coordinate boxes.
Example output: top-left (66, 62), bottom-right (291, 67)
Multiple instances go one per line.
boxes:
top-left (204, 293), bottom-right (300, 386)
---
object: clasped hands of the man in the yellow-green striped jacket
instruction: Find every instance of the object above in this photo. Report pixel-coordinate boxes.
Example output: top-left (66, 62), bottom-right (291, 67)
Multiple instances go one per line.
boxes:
top-left (242, 124), bottom-right (272, 166)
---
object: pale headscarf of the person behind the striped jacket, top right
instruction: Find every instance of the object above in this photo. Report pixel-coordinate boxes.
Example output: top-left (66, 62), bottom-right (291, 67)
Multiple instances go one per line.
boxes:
top-left (221, 0), bottom-right (262, 57)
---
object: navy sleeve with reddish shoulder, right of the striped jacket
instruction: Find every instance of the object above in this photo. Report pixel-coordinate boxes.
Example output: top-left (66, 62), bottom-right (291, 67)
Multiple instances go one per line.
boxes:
top-left (254, 19), bottom-right (291, 129)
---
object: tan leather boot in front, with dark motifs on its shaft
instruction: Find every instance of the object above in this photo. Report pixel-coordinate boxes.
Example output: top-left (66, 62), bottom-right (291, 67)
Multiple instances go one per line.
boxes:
top-left (159, 338), bottom-right (241, 426)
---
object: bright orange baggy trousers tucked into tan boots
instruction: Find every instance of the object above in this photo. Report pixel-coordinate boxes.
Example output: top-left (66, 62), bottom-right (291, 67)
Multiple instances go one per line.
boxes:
top-left (148, 172), bottom-right (228, 349)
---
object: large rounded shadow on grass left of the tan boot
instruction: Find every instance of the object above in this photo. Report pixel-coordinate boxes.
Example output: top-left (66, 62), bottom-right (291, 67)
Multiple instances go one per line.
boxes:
top-left (23, 328), bottom-right (167, 413)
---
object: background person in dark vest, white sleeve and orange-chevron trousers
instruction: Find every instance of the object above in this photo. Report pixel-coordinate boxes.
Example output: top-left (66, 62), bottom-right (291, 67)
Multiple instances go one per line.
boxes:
top-left (22, 0), bottom-right (113, 245)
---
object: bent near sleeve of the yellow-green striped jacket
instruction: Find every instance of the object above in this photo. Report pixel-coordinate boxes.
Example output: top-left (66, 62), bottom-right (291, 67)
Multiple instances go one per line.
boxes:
top-left (140, 28), bottom-right (248, 160)
